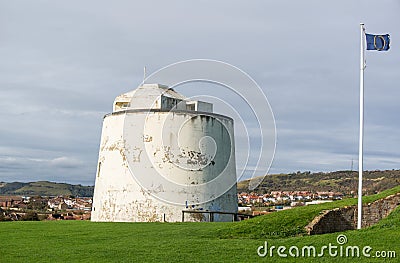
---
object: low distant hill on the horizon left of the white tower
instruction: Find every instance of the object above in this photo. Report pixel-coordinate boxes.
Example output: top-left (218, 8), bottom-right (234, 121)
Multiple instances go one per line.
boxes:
top-left (0, 181), bottom-right (94, 197)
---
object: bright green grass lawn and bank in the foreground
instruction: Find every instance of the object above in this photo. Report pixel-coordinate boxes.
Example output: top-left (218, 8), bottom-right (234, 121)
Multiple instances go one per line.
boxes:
top-left (0, 188), bottom-right (400, 262)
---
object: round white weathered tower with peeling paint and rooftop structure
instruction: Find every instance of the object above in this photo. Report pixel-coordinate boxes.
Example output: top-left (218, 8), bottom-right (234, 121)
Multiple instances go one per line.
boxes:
top-left (91, 84), bottom-right (237, 222)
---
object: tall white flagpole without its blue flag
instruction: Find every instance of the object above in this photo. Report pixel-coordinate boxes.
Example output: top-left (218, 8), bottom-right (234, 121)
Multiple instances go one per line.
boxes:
top-left (357, 23), bottom-right (365, 229)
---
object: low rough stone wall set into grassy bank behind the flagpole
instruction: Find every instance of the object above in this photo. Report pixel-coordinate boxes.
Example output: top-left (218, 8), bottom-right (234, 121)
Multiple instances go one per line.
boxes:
top-left (306, 193), bottom-right (400, 235)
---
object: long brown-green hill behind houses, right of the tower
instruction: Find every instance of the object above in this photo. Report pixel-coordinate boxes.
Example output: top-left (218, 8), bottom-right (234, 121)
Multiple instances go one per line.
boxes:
top-left (238, 170), bottom-right (400, 195)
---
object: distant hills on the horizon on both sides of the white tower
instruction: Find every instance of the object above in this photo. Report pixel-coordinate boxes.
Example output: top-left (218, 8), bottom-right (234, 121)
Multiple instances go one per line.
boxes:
top-left (0, 170), bottom-right (400, 197)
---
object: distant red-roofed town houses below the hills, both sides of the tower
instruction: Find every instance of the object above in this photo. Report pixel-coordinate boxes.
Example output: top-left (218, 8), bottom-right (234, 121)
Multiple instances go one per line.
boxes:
top-left (0, 191), bottom-right (343, 221)
